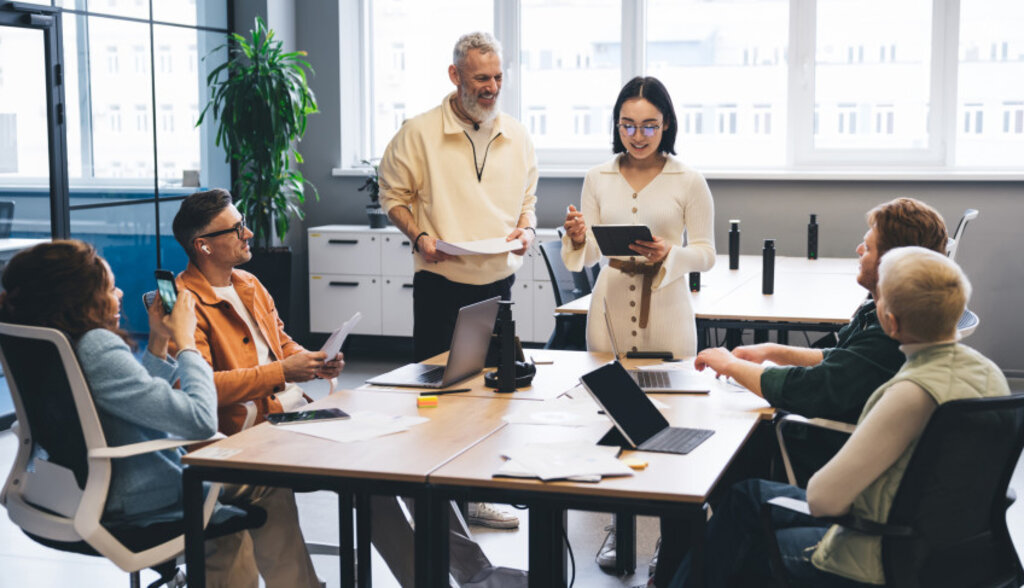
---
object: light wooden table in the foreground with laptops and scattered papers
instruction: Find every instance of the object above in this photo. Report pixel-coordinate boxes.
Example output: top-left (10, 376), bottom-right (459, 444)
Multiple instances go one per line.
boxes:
top-left (183, 350), bottom-right (771, 588)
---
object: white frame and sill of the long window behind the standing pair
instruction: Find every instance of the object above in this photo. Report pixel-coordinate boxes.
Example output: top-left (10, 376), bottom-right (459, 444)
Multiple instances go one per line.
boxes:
top-left (334, 0), bottom-right (1024, 180)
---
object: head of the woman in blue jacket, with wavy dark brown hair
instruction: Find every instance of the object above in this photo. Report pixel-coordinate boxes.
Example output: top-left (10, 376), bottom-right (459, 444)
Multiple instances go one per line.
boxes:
top-left (0, 240), bottom-right (132, 344)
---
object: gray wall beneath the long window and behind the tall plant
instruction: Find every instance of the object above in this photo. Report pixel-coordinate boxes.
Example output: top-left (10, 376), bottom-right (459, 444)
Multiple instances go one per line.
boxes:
top-left (253, 0), bottom-right (1024, 374)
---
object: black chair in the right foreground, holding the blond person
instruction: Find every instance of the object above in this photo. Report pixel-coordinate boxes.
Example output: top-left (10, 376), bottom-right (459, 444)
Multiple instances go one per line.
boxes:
top-left (763, 394), bottom-right (1024, 588)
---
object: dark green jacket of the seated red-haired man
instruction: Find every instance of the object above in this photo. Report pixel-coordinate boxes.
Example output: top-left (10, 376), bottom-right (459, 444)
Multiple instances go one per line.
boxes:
top-left (761, 299), bottom-right (904, 423)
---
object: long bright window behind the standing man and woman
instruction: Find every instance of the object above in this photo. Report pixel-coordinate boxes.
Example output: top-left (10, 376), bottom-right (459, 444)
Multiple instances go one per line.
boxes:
top-left (346, 0), bottom-right (1024, 173)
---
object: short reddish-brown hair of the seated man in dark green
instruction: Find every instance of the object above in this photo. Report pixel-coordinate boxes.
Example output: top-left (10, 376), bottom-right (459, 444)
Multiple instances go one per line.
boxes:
top-left (867, 198), bottom-right (948, 258)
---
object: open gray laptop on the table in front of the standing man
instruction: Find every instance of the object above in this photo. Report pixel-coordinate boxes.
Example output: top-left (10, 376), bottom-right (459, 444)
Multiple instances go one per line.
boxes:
top-left (367, 296), bottom-right (501, 388)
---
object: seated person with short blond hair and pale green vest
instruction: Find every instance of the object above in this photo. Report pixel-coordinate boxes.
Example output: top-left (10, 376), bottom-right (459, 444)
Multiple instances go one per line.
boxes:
top-left (671, 247), bottom-right (1010, 588)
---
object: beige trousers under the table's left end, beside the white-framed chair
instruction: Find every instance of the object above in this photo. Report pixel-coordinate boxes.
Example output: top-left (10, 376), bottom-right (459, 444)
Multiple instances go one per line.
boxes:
top-left (206, 486), bottom-right (319, 588)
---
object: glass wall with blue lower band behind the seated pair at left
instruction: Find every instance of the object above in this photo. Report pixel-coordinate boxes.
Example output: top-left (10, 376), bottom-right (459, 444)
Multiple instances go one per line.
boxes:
top-left (0, 0), bottom-right (230, 332)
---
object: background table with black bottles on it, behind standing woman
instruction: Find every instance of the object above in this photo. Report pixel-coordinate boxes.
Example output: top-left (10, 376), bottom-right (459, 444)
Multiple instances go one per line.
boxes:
top-left (555, 255), bottom-right (867, 346)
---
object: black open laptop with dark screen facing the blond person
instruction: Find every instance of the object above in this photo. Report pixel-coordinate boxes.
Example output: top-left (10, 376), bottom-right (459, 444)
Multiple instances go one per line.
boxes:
top-left (580, 361), bottom-right (715, 454)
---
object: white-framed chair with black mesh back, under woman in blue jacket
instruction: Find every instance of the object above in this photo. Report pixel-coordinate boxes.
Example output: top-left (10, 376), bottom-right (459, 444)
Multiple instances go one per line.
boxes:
top-left (0, 323), bottom-right (266, 587)
